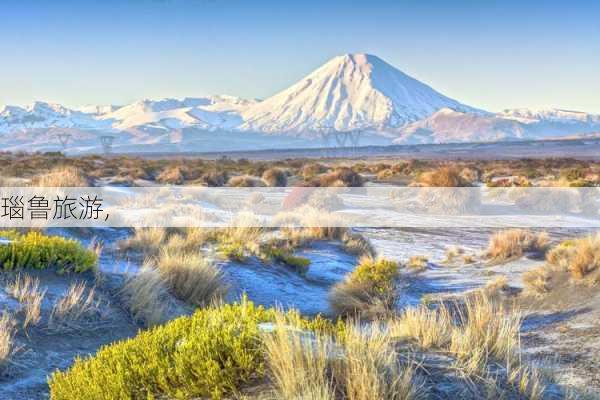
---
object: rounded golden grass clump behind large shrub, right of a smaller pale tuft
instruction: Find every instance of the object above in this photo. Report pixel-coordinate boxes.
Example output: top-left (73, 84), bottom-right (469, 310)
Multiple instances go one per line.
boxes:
top-left (156, 250), bottom-right (228, 306)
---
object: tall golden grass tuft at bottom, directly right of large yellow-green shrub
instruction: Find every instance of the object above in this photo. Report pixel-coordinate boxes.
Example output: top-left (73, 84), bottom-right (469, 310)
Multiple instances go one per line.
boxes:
top-left (264, 313), bottom-right (335, 400)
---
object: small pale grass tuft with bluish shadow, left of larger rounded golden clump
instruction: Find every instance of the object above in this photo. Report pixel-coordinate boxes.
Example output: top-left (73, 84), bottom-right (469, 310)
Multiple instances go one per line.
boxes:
top-left (120, 263), bottom-right (167, 327)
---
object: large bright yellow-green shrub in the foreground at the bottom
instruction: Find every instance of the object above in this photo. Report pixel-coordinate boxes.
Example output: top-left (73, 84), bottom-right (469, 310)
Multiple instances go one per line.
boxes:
top-left (49, 299), bottom-right (337, 400)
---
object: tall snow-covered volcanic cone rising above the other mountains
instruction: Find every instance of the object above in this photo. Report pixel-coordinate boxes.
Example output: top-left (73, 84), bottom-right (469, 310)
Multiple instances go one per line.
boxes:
top-left (240, 54), bottom-right (478, 133)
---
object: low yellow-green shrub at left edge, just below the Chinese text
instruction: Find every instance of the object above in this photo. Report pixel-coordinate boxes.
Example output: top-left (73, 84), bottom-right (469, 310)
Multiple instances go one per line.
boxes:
top-left (0, 231), bottom-right (98, 272)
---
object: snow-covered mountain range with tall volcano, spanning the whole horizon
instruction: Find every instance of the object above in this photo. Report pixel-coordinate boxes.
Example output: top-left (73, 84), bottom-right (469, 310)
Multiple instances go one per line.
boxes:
top-left (0, 54), bottom-right (600, 152)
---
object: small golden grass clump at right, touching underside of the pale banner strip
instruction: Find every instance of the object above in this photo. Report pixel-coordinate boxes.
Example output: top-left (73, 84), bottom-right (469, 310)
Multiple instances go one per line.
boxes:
top-left (485, 229), bottom-right (549, 263)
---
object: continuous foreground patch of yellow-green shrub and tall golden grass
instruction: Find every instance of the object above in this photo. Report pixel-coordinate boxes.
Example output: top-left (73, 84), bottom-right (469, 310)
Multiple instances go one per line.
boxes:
top-left (49, 294), bottom-right (547, 400)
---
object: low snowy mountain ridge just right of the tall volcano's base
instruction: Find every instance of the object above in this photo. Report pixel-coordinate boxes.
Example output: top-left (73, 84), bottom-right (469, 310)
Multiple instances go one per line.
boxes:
top-left (394, 108), bottom-right (527, 144)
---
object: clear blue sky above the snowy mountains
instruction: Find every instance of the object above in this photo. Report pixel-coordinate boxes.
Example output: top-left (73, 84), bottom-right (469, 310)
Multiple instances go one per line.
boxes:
top-left (0, 0), bottom-right (600, 113)
